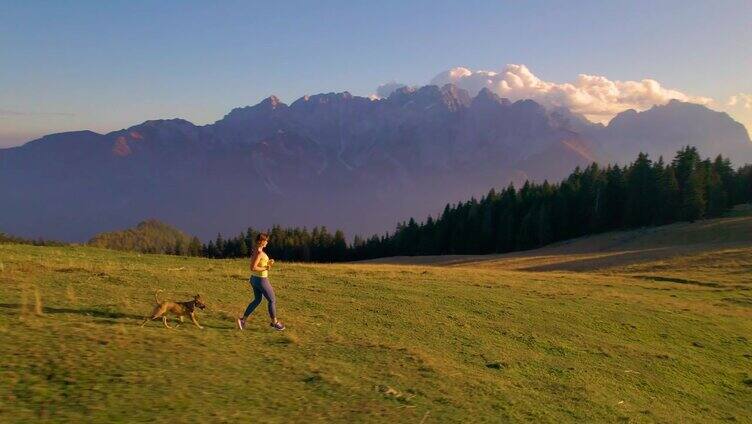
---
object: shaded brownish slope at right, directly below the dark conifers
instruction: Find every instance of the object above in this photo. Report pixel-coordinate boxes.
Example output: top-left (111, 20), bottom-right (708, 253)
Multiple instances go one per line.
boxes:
top-left (361, 205), bottom-right (752, 272)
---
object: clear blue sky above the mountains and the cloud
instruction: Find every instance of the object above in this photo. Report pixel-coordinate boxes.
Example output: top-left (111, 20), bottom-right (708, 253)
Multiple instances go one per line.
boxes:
top-left (0, 0), bottom-right (752, 147)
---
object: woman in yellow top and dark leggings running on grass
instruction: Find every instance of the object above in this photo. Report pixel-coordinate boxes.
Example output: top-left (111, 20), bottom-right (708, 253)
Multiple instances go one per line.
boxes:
top-left (237, 233), bottom-right (285, 331)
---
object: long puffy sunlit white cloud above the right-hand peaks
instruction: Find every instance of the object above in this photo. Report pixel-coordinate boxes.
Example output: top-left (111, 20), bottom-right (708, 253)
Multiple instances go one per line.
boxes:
top-left (431, 65), bottom-right (713, 122)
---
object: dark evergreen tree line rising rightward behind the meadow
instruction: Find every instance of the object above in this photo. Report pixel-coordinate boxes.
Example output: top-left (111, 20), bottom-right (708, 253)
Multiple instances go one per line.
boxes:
top-left (201, 146), bottom-right (752, 262)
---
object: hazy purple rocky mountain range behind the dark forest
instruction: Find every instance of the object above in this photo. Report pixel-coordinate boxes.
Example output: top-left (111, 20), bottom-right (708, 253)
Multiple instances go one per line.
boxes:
top-left (0, 84), bottom-right (752, 241)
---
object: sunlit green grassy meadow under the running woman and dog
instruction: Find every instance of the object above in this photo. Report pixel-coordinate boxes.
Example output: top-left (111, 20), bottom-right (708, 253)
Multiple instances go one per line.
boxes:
top-left (0, 245), bottom-right (752, 423)
